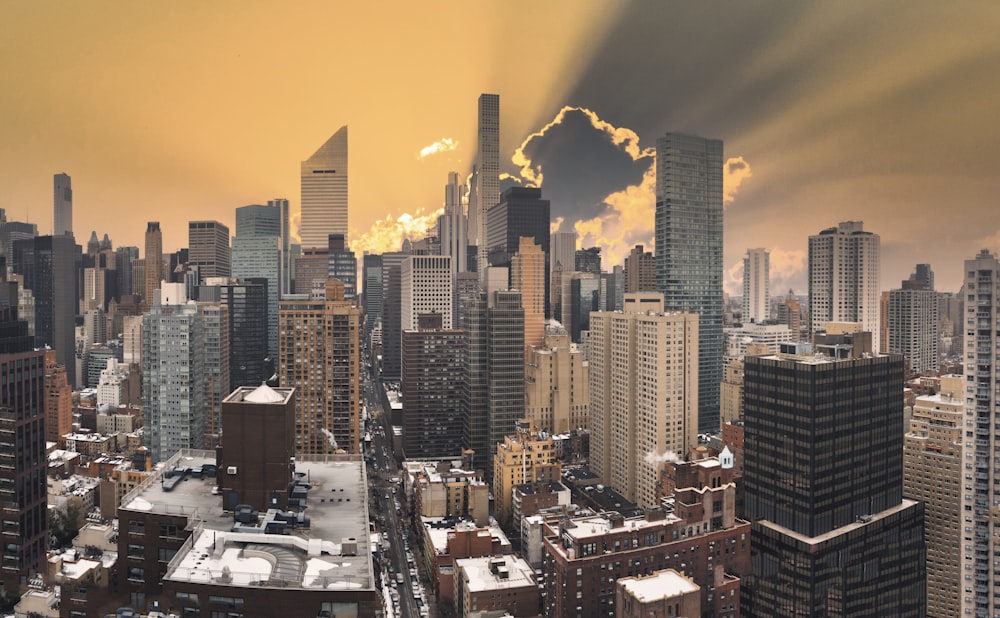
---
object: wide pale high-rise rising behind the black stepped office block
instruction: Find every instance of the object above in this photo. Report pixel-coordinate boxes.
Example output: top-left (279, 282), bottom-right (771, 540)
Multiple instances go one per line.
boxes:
top-left (809, 221), bottom-right (881, 352)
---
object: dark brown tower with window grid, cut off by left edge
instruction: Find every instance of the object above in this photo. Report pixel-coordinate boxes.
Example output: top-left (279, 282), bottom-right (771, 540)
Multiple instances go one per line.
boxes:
top-left (0, 306), bottom-right (46, 595)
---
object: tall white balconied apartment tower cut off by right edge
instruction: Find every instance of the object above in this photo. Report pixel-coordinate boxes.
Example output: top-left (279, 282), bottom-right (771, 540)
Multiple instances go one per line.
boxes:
top-left (959, 249), bottom-right (1000, 618)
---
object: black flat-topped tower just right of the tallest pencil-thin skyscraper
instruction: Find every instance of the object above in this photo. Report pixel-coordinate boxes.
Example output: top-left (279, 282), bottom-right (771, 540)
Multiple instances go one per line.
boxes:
top-left (484, 187), bottom-right (551, 312)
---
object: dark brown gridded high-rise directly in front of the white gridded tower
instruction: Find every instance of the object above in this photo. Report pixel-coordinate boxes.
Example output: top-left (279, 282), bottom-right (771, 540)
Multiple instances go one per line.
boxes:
top-left (400, 313), bottom-right (465, 459)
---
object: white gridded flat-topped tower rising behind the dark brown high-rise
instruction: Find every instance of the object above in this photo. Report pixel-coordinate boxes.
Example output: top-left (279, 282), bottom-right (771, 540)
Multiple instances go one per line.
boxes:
top-left (400, 255), bottom-right (454, 330)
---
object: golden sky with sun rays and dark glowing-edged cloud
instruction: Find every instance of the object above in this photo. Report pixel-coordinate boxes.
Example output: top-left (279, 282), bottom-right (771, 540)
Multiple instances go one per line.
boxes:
top-left (0, 0), bottom-right (1000, 295)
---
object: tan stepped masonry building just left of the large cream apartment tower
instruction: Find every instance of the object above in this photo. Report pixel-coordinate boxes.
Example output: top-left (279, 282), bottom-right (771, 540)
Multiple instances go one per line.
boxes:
top-left (524, 325), bottom-right (590, 433)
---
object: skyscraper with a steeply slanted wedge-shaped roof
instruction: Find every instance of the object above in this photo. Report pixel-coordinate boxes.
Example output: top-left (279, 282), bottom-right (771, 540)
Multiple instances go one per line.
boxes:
top-left (299, 125), bottom-right (348, 249)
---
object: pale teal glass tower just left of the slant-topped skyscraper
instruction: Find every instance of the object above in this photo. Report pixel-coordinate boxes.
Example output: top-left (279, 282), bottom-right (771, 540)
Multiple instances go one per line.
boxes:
top-left (233, 204), bottom-right (281, 356)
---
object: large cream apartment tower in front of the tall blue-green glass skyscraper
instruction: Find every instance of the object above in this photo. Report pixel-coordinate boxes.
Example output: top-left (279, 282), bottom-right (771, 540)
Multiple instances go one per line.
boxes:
top-left (589, 292), bottom-right (700, 509)
